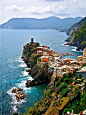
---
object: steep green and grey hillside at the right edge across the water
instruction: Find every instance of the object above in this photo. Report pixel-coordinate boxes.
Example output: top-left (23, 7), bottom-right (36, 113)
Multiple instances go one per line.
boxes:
top-left (66, 17), bottom-right (86, 50)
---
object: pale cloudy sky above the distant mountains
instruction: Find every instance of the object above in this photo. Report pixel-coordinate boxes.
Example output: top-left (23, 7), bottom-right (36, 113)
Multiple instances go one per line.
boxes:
top-left (0, 0), bottom-right (86, 24)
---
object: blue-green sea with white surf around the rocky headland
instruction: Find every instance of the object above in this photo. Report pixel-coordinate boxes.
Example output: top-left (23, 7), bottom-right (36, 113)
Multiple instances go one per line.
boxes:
top-left (0, 29), bottom-right (82, 115)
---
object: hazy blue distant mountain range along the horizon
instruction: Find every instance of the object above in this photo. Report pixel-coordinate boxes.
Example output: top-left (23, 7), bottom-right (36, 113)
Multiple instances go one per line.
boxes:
top-left (0, 17), bottom-right (82, 31)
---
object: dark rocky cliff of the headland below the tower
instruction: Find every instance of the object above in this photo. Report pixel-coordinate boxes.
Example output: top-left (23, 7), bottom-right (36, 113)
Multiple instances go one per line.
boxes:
top-left (22, 43), bottom-right (51, 87)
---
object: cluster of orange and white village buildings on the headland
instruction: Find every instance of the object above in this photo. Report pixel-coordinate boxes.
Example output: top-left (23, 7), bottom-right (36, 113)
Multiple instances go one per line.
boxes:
top-left (37, 37), bottom-right (86, 81)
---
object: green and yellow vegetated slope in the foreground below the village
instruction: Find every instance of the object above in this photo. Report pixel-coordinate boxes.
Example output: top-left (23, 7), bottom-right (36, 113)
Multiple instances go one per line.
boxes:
top-left (24, 72), bottom-right (86, 115)
